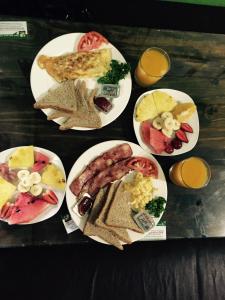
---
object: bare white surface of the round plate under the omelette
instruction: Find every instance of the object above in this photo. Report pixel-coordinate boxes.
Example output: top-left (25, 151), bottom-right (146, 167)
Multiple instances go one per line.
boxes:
top-left (30, 33), bottom-right (132, 130)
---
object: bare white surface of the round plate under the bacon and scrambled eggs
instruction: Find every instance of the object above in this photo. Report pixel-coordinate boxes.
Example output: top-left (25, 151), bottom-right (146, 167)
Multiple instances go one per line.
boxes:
top-left (66, 140), bottom-right (167, 244)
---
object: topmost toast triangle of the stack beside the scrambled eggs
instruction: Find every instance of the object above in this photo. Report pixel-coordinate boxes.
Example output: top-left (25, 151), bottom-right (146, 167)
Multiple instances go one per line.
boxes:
top-left (105, 184), bottom-right (143, 233)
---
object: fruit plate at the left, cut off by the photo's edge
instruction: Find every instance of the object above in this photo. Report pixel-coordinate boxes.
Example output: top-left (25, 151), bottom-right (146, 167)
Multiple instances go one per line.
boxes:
top-left (0, 146), bottom-right (66, 225)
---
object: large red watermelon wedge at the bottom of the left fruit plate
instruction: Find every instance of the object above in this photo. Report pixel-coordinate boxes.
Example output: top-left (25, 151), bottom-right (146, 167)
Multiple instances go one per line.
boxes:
top-left (8, 193), bottom-right (49, 225)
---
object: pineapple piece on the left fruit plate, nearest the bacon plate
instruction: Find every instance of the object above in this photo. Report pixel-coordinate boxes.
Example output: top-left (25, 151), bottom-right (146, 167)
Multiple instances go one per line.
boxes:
top-left (41, 164), bottom-right (66, 190)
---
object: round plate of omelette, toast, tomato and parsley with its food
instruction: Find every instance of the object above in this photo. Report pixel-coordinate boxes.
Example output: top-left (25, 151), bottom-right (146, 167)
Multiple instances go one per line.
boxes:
top-left (30, 31), bottom-right (131, 130)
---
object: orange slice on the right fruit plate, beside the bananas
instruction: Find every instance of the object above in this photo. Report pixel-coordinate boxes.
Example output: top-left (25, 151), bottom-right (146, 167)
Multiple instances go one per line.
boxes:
top-left (172, 102), bottom-right (196, 123)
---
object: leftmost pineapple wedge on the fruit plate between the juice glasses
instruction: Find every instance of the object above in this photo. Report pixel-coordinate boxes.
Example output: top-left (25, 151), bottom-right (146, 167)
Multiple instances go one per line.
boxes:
top-left (136, 94), bottom-right (158, 122)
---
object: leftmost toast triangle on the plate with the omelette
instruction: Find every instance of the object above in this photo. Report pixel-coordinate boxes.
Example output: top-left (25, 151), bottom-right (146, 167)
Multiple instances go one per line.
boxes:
top-left (34, 80), bottom-right (77, 112)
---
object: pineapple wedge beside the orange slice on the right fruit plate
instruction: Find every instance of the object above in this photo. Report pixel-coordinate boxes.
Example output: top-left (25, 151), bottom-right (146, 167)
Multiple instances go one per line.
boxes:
top-left (152, 91), bottom-right (177, 115)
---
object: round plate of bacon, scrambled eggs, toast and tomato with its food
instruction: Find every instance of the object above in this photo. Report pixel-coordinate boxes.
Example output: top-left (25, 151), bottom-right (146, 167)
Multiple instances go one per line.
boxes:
top-left (66, 140), bottom-right (167, 250)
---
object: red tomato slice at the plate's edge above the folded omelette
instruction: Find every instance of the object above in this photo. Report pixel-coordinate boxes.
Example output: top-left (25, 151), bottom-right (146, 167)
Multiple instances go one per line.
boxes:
top-left (77, 31), bottom-right (108, 52)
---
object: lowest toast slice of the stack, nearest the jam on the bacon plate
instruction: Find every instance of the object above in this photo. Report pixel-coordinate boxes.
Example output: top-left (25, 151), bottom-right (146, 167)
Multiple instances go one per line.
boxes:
top-left (83, 189), bottom-right (123, 250)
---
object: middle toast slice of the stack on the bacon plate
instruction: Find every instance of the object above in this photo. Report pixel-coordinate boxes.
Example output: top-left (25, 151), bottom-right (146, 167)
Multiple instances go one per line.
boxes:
top-left (95, 181), bottom-right (131, 244)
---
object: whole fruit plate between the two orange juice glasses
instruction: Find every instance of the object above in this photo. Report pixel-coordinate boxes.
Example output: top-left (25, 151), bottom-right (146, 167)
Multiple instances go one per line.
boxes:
top-left (133, 89), bottom-right (199, 156)
